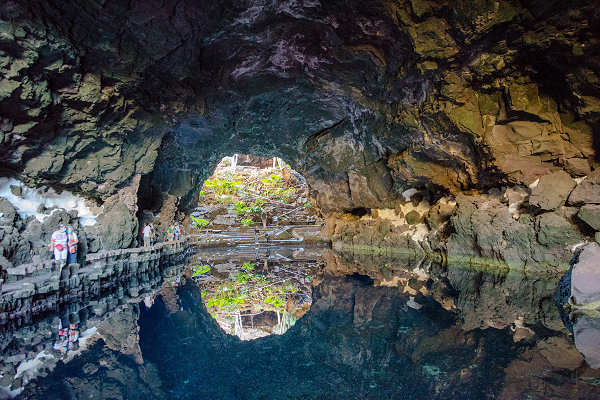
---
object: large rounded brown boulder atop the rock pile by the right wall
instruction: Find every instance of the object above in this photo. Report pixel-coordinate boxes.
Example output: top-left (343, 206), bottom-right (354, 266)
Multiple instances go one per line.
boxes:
top-left (529, 171), bottom-right (576, 211)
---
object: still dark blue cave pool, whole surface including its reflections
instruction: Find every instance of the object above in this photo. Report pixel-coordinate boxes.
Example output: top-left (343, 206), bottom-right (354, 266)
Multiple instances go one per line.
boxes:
top-left (2, 248), bottom-right (600, 400)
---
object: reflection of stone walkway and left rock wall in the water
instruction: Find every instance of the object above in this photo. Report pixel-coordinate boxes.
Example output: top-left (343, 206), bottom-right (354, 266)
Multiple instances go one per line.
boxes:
top-left (0, 263), bottom-right (184, 397)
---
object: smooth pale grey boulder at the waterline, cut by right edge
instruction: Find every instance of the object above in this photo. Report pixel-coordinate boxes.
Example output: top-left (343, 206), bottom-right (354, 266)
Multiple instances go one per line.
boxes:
top-left (571, 243), bottom-right (600, 305)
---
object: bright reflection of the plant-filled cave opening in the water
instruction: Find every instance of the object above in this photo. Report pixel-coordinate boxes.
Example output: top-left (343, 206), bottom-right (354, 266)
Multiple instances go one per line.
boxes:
top-left (190, 247), bottom-right (329, 340)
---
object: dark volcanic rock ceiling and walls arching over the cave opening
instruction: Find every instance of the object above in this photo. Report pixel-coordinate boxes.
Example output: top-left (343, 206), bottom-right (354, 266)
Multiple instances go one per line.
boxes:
top-left (0, 0), bottom-right (600, 265)
